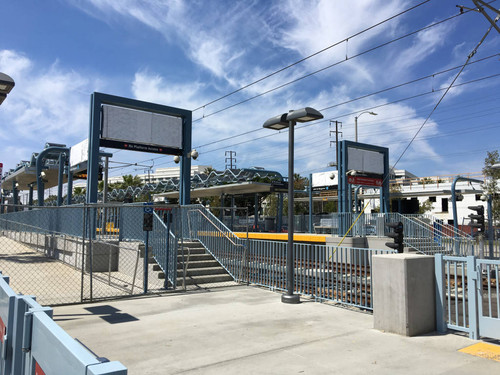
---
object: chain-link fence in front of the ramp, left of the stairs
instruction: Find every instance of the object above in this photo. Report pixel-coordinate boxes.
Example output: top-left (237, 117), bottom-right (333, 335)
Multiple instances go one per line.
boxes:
top-left (0, 205), bottom-right (173, 305)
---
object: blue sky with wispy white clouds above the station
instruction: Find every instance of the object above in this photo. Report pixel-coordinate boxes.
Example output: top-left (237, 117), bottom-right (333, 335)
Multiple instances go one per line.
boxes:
top-left (0, 0), bottom-right (500, 182)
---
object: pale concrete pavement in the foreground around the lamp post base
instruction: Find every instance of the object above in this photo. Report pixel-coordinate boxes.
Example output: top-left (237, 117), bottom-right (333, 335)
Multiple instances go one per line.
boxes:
top-left (54, 286), bottom-right (500, 375)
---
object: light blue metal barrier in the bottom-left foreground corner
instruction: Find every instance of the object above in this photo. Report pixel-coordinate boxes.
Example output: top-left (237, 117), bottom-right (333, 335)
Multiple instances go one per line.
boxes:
top-left (0, 274), bottom-right (127, 375)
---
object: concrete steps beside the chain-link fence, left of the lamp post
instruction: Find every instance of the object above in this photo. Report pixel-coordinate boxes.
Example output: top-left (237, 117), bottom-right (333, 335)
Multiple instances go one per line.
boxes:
top-left (153, 241), bottom-right (234, 288)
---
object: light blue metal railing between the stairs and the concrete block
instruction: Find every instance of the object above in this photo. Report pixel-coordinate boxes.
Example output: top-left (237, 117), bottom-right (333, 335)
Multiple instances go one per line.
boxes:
top-left (243, 240), bottom-right (394, 310)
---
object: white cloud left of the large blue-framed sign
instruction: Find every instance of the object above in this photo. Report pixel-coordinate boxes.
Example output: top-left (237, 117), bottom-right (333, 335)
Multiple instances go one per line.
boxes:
top-left (0, 50), bottom-right (99, 172)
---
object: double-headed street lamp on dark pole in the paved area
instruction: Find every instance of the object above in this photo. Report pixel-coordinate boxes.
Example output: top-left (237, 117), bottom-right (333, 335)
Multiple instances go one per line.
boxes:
top-left (263, 107), bottom-right (323, 304)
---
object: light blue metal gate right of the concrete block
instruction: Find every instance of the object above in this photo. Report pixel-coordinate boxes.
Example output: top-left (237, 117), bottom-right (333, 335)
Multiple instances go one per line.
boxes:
top-left (435, 254), bottom-right (500, 340)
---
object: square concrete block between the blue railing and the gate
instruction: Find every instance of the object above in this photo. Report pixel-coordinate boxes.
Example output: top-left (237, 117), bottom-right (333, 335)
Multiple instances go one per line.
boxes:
top-left (372, 254), bottom-right (436, 336)
